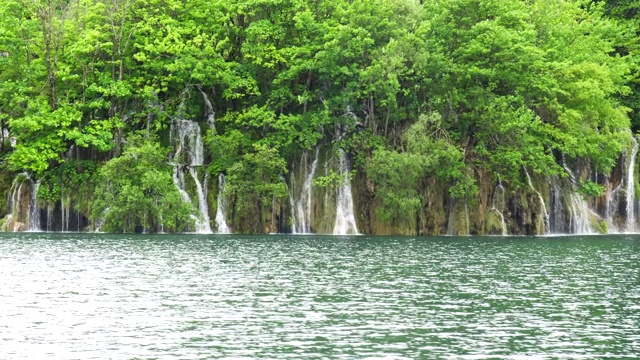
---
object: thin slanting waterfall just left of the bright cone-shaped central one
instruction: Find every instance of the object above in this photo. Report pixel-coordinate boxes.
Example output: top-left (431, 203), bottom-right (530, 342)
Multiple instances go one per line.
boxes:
top-left (289, 148), bottom-right (318, 234)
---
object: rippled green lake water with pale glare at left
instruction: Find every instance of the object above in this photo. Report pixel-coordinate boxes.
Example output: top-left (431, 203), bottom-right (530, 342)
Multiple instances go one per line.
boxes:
top-left (0, 233), bottom-right (640, 359)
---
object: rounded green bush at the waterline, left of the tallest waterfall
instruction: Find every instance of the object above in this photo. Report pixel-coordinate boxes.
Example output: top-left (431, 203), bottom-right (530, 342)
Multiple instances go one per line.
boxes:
top-left (91, 135), bottom-right (195, 232)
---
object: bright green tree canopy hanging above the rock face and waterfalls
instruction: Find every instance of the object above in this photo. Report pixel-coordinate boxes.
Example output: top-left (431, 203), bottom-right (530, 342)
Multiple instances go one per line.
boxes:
top-left (0, 0), bottom-right (640, 230)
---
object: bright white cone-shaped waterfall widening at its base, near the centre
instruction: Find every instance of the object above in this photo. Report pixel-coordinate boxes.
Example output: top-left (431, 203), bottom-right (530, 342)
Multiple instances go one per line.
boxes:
top-left (333, 149), bottom-right (358, 235)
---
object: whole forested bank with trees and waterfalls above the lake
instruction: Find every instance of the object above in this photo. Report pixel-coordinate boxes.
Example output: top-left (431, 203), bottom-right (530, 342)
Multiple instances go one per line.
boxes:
top-left (0, 0), bottom-right (640, 235)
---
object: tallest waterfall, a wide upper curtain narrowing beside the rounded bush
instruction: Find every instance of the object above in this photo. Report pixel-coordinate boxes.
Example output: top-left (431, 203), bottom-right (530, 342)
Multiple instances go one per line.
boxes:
top-left (171, 119), bottom-right (211, 234)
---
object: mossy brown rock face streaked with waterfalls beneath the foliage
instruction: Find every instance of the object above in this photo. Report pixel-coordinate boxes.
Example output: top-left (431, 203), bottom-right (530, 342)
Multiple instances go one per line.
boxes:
top-left (0, 136), bottom-right (640, 235)
